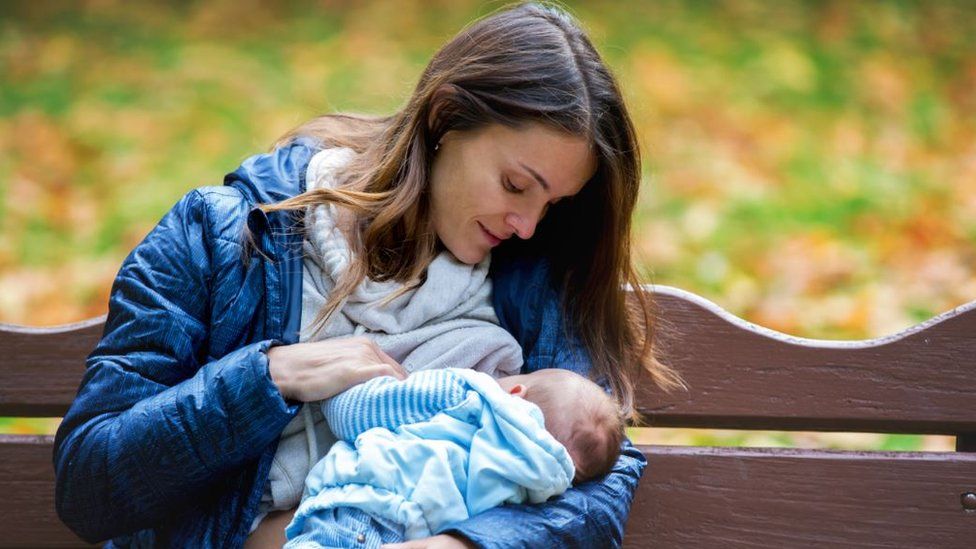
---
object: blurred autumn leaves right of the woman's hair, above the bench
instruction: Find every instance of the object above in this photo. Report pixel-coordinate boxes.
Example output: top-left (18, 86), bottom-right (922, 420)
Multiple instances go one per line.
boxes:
top-left (601, 2), bottom-right (976, 338)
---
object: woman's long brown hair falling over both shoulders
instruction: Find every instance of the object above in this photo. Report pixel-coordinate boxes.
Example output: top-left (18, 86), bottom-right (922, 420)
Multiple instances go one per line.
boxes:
top-left (248, 3), bottom-right (681, 418)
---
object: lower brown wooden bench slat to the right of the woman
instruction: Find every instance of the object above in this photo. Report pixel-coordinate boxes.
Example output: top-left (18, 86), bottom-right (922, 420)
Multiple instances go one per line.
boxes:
top-left (625, 446), bottom-right (976, 548)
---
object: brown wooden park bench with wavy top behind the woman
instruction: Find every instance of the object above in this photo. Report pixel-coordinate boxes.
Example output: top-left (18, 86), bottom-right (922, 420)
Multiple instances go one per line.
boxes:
top-left (0, 286), bottom-right (976, 548)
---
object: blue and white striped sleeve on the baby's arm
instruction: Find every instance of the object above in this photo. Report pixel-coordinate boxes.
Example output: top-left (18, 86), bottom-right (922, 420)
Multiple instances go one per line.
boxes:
top-left (322, 368), bottom-right (466, 442)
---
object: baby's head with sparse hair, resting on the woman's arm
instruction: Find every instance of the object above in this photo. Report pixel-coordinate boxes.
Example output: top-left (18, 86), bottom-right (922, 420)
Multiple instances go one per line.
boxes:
top-left (498, 368), bottom-right (624, 483)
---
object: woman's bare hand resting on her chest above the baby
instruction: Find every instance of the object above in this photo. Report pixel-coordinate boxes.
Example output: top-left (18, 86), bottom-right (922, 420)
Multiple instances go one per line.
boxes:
top-left (268, 337), bottom-right (407, 402)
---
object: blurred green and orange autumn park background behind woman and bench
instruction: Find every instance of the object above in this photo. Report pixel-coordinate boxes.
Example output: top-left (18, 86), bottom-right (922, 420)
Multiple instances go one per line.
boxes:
top-left (0, 0), bottom-right (976, 450)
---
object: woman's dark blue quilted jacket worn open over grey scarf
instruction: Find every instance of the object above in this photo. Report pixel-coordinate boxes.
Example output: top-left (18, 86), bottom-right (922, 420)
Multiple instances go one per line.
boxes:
top-left (54, 139), bottom-right (645, 548)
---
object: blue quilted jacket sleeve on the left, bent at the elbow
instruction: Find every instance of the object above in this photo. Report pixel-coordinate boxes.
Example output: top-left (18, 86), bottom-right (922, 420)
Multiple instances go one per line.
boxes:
top-left (54, 186), bottom-right (297, 542)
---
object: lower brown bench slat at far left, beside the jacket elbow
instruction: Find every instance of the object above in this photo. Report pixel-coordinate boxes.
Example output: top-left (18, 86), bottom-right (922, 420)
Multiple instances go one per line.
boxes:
top-left (0, 435), bottom-right (95, 547)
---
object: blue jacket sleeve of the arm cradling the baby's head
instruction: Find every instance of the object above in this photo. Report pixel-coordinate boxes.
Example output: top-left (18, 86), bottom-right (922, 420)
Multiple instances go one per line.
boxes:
top-left (441, 252), bottom-right (647, 548)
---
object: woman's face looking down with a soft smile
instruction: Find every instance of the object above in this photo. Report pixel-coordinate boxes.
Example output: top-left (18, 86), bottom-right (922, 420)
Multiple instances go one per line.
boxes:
top-left (430, 123), bottom-right (597, 264)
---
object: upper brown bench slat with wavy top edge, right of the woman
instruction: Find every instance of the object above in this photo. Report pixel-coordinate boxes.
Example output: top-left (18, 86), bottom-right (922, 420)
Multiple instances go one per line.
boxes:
top-left (637, 286), bottom-right (976, 434)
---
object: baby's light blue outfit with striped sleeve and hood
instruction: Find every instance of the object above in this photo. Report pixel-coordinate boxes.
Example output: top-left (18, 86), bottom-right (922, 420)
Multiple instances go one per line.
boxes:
top-left (285, 368), bottom-right (575, 539)
